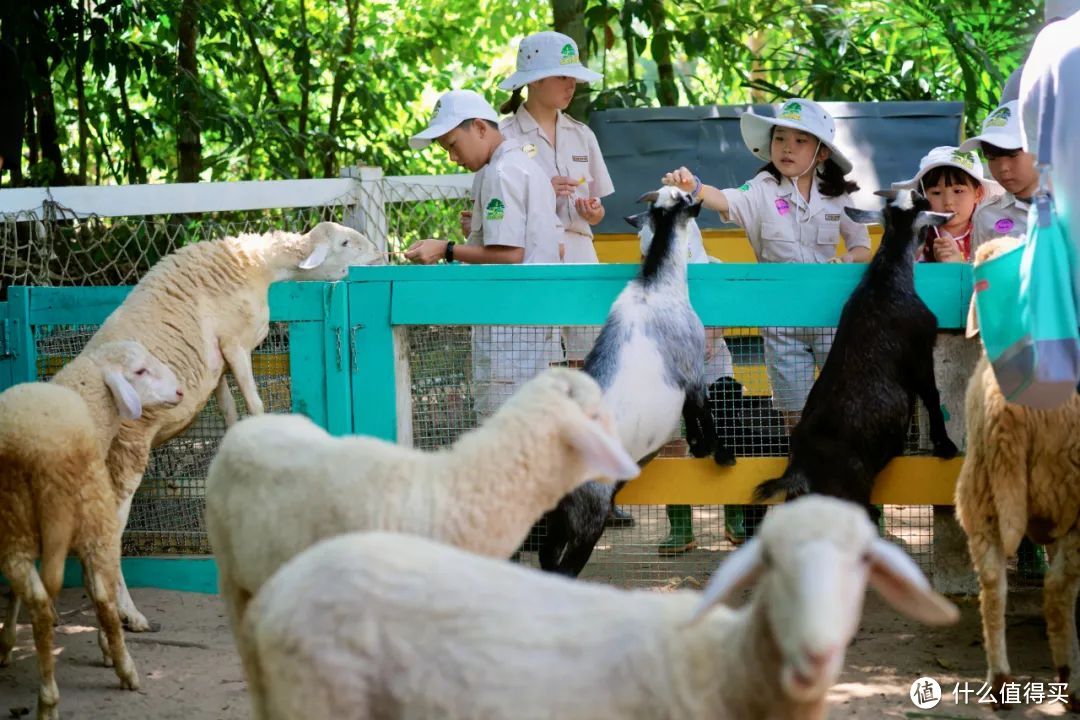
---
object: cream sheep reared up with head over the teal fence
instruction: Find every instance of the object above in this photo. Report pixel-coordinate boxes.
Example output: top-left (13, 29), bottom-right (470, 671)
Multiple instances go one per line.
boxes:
top-left (86, 222), bottom-right (382, 630)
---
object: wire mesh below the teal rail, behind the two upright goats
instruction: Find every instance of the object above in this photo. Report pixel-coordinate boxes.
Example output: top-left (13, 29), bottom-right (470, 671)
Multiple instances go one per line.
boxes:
top-left (407, 326), bottom-right (933, 586)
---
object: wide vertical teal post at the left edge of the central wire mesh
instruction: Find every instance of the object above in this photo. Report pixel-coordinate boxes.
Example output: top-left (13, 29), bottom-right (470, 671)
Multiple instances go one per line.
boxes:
top-left (349, 283), bottom-right (397, 440)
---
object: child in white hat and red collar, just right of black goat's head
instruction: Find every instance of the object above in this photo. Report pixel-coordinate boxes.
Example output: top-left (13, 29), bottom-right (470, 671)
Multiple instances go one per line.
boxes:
top-left (892, 145), bottom-right (1000, 262)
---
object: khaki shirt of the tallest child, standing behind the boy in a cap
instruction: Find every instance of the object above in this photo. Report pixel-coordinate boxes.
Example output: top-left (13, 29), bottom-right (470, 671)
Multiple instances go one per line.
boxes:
top-left (499, 104), bottom-right (615, 237)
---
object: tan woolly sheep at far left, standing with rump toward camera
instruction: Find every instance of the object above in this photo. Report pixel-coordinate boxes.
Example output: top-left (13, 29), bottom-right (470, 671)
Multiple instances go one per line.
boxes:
top-left (0, 341), bottom-right (184, 720)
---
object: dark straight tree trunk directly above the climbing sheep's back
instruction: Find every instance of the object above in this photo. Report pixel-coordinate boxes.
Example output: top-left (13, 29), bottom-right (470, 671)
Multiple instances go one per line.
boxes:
top-left (176, 0), bottom-right (202, 182)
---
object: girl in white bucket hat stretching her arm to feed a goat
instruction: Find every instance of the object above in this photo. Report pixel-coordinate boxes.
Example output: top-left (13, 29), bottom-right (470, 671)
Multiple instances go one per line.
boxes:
top-left (662, 98), bottom-right (870, 543)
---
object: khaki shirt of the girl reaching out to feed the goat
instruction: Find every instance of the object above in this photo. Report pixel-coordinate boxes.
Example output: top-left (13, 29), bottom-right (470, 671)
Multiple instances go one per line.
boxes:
top-left (720, 171), bottom-right (870, 262)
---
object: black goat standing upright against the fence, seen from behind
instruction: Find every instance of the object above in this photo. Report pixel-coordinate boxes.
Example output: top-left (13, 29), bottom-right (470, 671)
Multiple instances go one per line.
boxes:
top-left (754, 191), bottom-right (957, 520)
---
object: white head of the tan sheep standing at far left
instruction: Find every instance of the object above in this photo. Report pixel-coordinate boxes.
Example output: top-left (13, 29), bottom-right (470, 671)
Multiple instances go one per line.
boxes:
top-left (90, 340), bottom-right (184, 420)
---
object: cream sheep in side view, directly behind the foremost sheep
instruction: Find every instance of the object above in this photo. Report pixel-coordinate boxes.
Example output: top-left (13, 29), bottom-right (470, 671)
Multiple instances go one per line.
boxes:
top-left (206, 368), bottom-right (638, 708)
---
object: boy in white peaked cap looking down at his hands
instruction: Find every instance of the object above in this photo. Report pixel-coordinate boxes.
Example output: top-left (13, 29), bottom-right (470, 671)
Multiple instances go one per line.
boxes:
top-left (405, 90), bottom-right (563, 418)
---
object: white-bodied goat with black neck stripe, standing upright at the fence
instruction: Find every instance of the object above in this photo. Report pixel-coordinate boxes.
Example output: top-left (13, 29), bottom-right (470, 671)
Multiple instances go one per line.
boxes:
top-left (539, 187), bottom-right (721, 576)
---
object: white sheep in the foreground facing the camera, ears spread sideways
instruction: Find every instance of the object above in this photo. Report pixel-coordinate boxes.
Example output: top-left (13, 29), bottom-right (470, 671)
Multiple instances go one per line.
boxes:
top-left (244, 497), bottom-right (959, 720)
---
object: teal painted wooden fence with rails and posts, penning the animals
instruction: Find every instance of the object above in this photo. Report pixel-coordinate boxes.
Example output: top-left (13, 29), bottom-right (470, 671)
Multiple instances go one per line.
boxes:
top-left (0, 263), bottom-right (972, 592)
